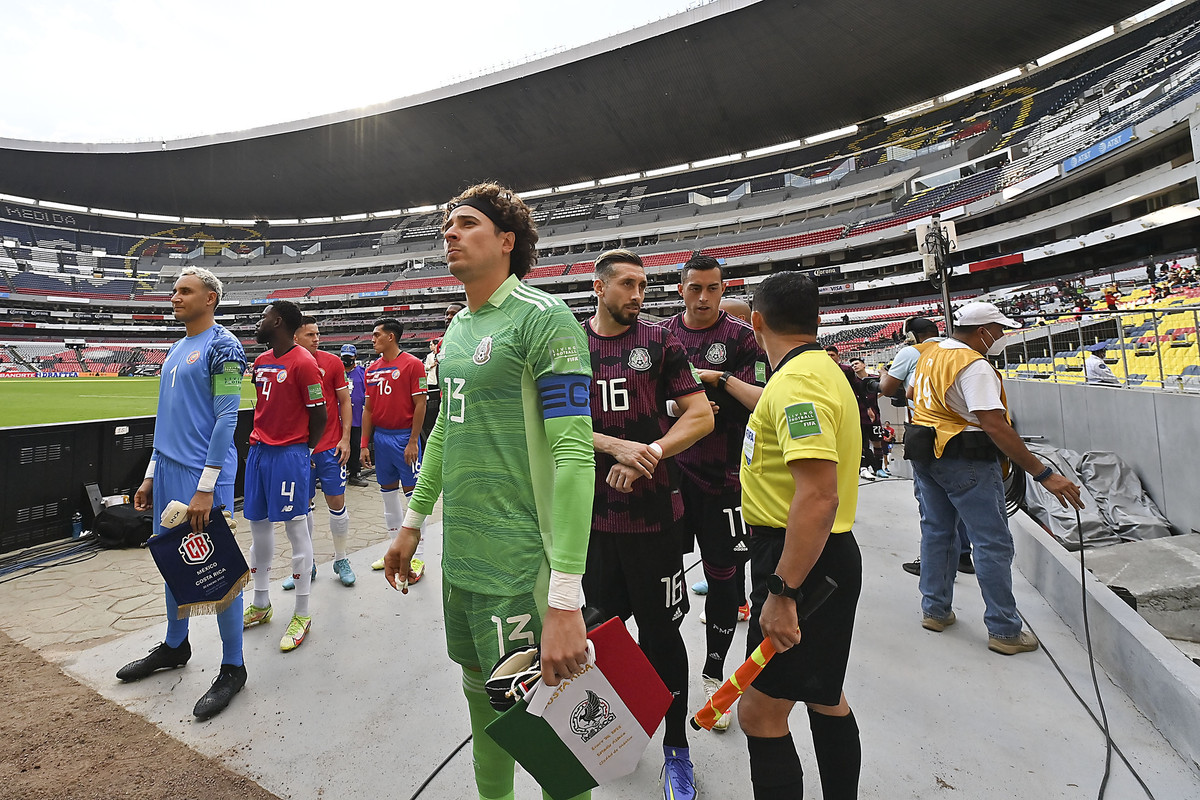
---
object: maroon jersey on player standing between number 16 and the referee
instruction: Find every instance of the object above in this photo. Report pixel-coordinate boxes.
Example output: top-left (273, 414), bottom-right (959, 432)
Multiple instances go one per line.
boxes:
top-left (662, 311), bottom-right (767, 494)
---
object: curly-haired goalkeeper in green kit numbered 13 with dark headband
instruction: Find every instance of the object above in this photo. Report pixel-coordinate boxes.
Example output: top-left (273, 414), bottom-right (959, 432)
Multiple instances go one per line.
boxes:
top-left (384, 184), bottom-right (595, 800)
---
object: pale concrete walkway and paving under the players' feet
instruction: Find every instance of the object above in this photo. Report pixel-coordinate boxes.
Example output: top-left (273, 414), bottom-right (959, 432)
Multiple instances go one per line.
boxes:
top-left (0, 480), bottom-right (1200, 800)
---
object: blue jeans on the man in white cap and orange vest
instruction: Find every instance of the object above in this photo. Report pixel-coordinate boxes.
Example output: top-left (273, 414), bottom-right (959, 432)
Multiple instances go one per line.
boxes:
top-left (912, 458), bottom-right (1021, 639)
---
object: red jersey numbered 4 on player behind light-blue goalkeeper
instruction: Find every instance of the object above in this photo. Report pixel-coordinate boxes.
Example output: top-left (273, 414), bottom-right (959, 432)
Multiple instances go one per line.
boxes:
top-left (250, 345), bottom-right (323, 445)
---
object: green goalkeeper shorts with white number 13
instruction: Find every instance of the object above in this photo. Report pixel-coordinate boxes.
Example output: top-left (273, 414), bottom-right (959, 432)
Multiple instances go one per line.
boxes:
top-left (442, 581), bottom-right (541, 674)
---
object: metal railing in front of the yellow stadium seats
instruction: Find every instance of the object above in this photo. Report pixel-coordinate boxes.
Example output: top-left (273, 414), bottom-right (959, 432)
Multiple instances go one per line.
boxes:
top-left (995, 305), bottom-right (1200, 392)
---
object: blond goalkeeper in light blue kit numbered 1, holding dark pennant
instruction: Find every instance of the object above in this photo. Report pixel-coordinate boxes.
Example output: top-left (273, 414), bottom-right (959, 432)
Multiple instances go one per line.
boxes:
top-left (116, 267), bottom-right (246, 720)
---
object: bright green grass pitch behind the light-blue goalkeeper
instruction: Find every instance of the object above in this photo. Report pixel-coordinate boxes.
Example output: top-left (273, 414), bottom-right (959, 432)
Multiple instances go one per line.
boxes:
top-left (0, 378), bottom-right (254, 428)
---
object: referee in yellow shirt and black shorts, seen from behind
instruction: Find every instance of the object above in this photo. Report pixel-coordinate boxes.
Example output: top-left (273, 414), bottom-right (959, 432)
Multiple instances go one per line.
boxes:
top-left (738, 272), bottom-right (863, 800)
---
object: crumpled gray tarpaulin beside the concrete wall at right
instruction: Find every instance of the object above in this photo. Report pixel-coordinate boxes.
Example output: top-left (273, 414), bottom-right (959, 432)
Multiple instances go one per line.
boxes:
top-left (1025, 444), bottom-right (1171, 549)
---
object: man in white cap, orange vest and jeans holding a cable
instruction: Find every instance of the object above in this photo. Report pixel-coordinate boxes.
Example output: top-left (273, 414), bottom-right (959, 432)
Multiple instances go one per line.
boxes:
top-left (905, 302), bottom-right (1082, 655)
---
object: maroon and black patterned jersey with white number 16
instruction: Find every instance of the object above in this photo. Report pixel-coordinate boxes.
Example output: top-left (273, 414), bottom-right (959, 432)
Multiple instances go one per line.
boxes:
top-left (583, 320), bottom-right (703, 534)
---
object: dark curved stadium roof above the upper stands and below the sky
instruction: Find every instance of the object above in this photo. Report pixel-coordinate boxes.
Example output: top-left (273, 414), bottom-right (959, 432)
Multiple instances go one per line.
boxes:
top-left (0, 0), bottom-right (1148, 219)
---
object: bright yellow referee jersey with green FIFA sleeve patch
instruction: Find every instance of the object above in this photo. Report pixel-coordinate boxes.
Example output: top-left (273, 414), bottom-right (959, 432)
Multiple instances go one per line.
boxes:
top-left (742, 348), bottom-right (863, 534)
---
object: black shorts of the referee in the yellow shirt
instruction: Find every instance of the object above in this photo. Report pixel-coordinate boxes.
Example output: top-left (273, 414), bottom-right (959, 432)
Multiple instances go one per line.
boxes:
top-left (746, 527), bottom-right (863, 705)
